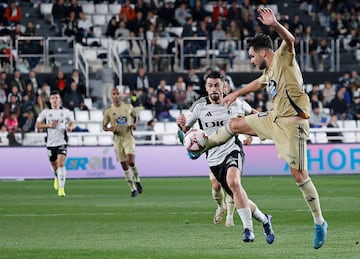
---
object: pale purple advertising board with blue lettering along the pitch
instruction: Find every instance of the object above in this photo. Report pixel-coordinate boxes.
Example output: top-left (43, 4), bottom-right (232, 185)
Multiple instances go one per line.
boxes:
top-left (0, 144), bottom-right (360, 180)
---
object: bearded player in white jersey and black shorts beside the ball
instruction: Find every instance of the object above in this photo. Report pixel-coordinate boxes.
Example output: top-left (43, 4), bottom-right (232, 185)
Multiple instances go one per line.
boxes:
top-left (177, 71), bottom-right (275, 244)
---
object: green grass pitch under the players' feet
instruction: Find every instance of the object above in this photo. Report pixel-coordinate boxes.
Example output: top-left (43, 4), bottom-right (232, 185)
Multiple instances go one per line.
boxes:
top-left (0, 175), bottom-right (360, 259)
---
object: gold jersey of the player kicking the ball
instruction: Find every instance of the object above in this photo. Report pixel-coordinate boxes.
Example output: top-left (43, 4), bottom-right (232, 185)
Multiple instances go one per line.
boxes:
top-left (260, 48), bottom-right (310, 119)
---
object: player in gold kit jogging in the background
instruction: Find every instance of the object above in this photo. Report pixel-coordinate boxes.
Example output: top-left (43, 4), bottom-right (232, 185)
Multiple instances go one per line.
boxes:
top-left (103, 88), bottom-right (143, 197)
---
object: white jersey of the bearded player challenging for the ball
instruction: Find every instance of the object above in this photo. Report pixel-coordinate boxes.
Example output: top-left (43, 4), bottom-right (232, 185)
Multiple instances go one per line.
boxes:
top-left (184, 97), bottom-right (252, 166)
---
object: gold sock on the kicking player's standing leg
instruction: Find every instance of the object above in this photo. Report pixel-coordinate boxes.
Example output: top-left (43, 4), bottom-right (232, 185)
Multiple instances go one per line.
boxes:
top-left (297, 178), bottom-right (322, 218)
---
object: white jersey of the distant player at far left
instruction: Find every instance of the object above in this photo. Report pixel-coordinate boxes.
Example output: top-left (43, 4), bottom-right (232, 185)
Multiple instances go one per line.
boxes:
top-left (37, 108), bottom-right (74, 147)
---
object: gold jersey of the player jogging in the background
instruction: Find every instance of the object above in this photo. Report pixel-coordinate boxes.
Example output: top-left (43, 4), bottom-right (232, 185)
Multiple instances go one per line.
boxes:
top-left (103, 102), bottom-right (137, 137)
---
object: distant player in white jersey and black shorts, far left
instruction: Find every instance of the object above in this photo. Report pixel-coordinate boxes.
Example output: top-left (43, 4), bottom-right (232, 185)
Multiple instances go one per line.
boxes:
top-left (36, 91), bottom-right (75, 197)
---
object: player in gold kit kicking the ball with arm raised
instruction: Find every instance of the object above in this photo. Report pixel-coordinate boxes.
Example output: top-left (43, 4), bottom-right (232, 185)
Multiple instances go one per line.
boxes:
top-left (196, 8), bottom-right (328, 249)
